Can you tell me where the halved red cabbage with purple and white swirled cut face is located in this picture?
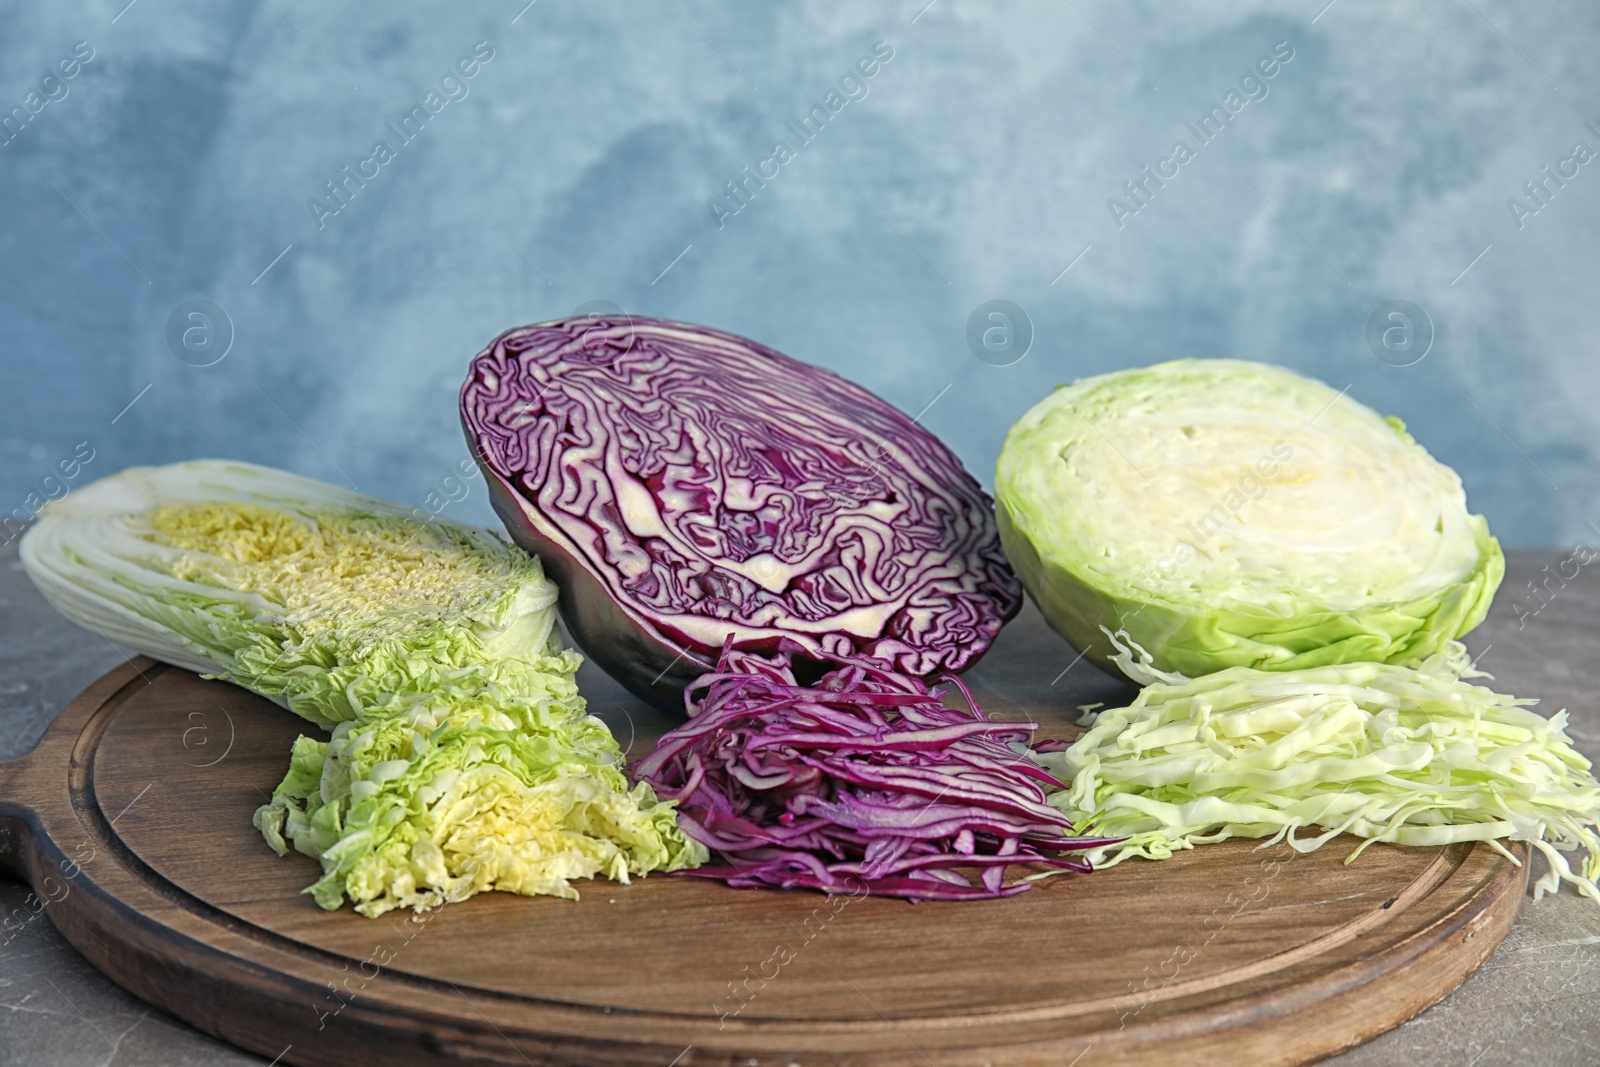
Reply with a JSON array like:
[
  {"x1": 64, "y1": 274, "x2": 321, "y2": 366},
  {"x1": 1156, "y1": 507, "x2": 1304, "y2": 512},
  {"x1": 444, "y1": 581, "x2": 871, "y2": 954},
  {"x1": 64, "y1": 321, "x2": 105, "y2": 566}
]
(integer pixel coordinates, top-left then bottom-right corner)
[{"x1": 461, "y1": 315, "x2": 1021, "y2": 709}]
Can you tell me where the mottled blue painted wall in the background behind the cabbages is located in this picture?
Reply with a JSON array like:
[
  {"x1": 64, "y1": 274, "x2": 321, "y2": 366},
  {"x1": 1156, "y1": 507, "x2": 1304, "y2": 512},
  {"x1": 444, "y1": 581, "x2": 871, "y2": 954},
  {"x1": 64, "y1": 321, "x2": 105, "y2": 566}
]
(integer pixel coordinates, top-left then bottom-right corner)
[{"x1": 0, "y1": 0, "x2": 1600, "y2": 544}]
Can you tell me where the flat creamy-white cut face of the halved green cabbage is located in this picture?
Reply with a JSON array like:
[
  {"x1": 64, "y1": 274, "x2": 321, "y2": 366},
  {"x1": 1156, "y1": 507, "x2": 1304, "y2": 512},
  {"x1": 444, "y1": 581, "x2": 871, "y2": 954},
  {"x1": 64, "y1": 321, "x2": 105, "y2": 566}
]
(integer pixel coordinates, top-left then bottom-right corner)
[{"x1": 1000, "y1": 360, "x2": 1478, "y2": 614}]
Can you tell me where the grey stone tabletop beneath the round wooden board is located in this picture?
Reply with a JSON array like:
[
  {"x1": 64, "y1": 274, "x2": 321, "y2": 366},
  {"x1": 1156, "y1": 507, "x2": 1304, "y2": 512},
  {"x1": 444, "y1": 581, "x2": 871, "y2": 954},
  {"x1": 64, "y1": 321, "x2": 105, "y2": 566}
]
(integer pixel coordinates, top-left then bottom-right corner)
[{"x1": 0, "y1": 547, "x2": 1600, "y2": 1067}]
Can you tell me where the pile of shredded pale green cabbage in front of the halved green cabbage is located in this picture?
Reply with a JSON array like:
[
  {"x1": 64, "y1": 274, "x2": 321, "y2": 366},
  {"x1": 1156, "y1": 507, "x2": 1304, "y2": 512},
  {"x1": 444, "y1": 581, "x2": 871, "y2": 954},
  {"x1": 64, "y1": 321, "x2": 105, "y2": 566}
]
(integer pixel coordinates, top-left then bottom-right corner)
[{"x1": 1037, "y1": 633, "x2": 1600, "y2": 902}]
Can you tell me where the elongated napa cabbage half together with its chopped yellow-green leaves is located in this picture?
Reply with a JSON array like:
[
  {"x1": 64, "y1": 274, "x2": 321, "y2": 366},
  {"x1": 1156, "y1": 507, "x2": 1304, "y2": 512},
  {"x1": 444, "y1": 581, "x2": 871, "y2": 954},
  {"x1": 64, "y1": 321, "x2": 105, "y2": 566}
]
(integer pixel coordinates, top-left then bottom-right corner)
[{"x1": 21, "y1": 461, "x2": 706, "y2": 915}]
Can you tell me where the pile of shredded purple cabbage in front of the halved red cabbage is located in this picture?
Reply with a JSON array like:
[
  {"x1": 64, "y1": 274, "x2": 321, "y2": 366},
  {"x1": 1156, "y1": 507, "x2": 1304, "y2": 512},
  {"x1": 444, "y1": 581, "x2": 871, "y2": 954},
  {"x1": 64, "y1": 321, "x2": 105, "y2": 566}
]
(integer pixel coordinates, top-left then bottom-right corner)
[{"x1": 632, "y1": 641, "x2": 1110, "y2": 901}]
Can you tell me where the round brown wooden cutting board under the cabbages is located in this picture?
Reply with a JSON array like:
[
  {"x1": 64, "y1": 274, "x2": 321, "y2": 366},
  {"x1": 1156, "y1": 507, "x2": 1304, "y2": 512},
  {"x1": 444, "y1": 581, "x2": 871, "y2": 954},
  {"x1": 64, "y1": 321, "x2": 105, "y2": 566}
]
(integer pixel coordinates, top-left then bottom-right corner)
[{"x1": 0, "y1": 613, "x2": 1528, "y2": 1067}]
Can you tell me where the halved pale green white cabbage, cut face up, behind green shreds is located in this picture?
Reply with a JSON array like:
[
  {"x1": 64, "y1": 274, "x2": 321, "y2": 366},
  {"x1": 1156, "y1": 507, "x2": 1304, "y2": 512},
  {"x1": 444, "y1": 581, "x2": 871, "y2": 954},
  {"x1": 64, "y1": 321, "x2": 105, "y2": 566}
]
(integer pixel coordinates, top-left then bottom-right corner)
[{"x1": 995, "y1": 360, "x2": 1506, "y2": 675}]
